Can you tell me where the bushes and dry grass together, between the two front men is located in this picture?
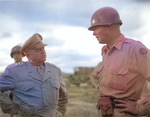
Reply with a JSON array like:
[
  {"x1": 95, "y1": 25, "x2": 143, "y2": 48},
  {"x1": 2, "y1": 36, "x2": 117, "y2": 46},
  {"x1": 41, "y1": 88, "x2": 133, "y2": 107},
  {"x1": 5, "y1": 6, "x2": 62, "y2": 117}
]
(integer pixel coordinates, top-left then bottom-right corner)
[{"x1": 63, "y1": 68, "x2": 101, "y2": 117}]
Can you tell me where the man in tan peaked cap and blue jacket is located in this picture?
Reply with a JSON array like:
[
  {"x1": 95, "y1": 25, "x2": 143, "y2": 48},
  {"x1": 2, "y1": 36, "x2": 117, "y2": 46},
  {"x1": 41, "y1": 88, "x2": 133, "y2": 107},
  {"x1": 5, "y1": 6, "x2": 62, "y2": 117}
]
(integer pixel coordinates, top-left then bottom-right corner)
[{"x1": 0, "y1": 33, "x2": 68, "y2": 117}]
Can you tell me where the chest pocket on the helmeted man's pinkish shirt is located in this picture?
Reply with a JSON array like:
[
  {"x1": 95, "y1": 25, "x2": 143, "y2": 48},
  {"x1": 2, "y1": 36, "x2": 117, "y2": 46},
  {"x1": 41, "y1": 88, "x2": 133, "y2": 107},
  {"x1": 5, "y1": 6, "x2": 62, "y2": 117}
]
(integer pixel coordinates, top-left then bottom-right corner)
[{"x1": 106, "y1": 67, "x2": 128, "y2": 91}]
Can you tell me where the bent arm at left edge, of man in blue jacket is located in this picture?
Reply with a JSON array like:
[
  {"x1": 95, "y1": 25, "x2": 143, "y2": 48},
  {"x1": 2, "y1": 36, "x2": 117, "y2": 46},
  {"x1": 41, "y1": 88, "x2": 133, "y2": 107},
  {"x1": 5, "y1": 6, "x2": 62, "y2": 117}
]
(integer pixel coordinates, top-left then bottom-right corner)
[{"x1": 0, "y1": 66, "x2": 19, "y2": 115}]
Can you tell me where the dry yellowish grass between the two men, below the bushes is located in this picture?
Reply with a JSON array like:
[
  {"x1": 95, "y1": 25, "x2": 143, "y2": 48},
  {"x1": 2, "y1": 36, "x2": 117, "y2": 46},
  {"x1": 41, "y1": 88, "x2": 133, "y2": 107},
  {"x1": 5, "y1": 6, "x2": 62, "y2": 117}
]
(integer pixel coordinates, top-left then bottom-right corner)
[{"x1": 65, "y1": 86, "x2": 100, "y2": 117}]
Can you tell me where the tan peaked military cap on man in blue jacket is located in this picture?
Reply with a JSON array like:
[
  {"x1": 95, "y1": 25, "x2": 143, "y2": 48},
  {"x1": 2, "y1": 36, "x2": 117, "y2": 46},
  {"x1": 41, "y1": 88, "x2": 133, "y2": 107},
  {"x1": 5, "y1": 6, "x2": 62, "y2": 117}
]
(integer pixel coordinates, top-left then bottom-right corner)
[{"x1": 20, "y1": 33, "x2": 47, "y2": 56}]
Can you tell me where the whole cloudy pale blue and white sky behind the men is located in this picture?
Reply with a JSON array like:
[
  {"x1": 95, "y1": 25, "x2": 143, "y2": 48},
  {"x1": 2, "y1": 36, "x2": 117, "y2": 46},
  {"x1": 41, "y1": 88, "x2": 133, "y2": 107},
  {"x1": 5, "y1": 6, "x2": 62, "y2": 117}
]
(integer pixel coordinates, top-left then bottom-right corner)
[{"x1": 0, "y1": 0, "x2": 150, "y2": 73}]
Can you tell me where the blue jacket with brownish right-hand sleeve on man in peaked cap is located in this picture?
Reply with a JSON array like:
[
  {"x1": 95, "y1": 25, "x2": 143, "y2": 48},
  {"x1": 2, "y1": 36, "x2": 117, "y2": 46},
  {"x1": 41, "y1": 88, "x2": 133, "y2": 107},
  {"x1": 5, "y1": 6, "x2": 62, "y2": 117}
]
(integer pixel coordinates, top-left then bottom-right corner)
[{"x1": 0, "y1": 62, "x2": 68, "y2": 117}]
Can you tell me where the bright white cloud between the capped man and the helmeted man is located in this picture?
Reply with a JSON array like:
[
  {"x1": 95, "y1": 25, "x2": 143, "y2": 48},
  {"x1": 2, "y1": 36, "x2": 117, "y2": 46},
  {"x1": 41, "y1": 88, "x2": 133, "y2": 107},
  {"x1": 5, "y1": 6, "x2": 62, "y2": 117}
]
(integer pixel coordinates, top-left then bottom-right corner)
[{"x1": 43, "y1": 25, "x2": 102, "y2": 72}]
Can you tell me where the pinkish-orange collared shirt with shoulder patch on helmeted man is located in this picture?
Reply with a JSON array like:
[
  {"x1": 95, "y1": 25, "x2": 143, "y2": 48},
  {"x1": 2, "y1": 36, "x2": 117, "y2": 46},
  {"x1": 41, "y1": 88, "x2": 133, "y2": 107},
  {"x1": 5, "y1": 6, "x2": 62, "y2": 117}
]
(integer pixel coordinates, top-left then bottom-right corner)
[{"x1": 99, "y1": 34, "x2": 150, "y2": 100}]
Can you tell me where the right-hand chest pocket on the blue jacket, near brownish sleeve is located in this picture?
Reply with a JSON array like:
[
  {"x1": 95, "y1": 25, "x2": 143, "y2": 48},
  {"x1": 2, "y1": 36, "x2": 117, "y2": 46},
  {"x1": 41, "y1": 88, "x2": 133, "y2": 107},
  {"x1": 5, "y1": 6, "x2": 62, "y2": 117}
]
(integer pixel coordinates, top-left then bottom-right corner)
[{"x1": 51, "y1": 81, "x2": 60, "y2": 101}]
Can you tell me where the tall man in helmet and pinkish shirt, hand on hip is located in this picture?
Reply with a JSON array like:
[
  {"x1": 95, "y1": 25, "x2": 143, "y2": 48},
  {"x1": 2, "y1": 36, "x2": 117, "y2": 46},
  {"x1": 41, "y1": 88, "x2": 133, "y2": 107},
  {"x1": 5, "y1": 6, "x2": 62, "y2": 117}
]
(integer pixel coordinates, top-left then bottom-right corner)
[{"x1": 89, "y1": 7, "x2": 150, "y2": 117}]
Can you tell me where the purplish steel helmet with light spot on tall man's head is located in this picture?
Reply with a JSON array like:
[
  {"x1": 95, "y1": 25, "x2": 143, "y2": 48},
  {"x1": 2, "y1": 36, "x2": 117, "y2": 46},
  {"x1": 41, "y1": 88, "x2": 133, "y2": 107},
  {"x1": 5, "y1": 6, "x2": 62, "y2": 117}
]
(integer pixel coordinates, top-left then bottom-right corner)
[{"x1": 88, "y1": 7, "x2": 122, "y2": 30}]
